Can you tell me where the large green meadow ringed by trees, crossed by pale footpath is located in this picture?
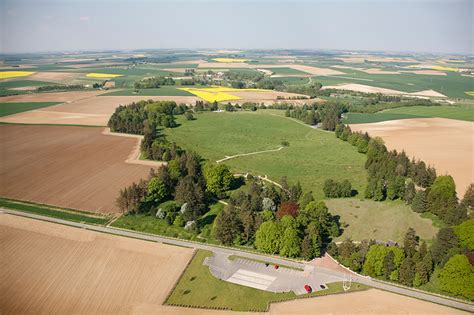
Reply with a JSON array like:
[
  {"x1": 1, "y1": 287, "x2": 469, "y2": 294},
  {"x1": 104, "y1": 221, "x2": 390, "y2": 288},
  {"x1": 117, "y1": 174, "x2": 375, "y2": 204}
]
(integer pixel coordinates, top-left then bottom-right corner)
[{"x1": 165, "y1": 110, "x2": 367, "y2": 198}]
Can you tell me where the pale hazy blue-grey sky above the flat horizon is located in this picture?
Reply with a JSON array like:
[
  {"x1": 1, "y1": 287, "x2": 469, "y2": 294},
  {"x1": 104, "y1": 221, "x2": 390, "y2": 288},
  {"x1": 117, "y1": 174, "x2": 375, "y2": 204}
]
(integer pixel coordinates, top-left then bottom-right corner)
[{"x1": 0, "y1": 0, "x2": 474, "y2": 54}]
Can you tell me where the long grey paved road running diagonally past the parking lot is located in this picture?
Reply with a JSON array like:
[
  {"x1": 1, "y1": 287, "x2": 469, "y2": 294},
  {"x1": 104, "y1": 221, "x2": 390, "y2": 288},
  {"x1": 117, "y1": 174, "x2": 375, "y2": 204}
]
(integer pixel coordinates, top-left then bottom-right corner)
[{"x1": 0, "y1": 208, "x2": 474, "y2": 312}]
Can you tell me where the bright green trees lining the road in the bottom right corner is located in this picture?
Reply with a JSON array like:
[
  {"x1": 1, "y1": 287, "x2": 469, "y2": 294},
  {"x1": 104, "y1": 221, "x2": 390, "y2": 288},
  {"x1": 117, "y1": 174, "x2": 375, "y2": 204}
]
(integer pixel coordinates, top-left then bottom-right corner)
[{"x1": 328, "y1": 219, "x2": 474, "y2": 300}]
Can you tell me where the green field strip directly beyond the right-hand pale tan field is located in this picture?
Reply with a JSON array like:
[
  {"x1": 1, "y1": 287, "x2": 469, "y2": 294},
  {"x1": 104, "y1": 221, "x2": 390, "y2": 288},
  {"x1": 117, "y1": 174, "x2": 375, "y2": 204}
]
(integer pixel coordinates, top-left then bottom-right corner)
[{"x1": 344, "y1": 105, "x2": 474, "y2": 124}]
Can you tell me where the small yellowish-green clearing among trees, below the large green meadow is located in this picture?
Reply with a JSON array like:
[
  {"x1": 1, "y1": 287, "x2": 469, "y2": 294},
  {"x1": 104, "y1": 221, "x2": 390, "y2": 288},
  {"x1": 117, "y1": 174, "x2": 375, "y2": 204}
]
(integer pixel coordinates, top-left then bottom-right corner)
[{"x1": 326, "y1": 198, "x2": 438, "y2": 243}]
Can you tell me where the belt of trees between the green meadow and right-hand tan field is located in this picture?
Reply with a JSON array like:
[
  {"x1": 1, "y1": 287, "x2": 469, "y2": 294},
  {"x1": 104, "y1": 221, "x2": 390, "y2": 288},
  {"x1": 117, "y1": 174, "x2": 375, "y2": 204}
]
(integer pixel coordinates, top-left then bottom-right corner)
[{"x1": 335, "y1": 125, "x2": 467, "y2": 225}]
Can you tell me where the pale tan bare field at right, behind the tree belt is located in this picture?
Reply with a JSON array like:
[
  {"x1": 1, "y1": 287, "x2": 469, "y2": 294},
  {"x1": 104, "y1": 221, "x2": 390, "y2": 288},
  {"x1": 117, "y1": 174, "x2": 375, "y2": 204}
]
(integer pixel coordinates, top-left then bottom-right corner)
[{"x1": 350, "y1": 118, "x2": 474, "y2": 197}]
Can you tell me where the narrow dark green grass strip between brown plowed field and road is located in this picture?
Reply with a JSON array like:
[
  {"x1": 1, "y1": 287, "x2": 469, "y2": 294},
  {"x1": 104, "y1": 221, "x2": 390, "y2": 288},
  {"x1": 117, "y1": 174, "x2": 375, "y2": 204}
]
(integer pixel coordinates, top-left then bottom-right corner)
[{"x1": 0, "y1": 198, "x2": 109, "y2": 225}]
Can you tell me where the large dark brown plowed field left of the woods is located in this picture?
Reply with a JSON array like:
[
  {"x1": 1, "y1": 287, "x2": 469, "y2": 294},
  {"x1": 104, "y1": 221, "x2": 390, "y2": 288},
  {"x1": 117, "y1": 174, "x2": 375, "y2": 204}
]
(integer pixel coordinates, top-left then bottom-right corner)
[{"x1": 0, "y1": 125, "x2": 155, "y2": 213}]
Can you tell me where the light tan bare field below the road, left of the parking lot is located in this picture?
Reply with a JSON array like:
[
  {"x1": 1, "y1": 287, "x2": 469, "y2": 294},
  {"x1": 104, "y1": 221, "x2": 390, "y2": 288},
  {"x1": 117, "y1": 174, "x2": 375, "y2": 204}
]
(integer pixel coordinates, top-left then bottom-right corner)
[{"x1": 0, "y1": 214, "x2": 192, "y2": 314}]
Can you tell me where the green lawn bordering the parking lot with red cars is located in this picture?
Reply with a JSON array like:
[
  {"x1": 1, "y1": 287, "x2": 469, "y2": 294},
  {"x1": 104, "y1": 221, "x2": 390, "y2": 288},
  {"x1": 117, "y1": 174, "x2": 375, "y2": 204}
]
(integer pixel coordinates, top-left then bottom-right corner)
[{"x1": 165, "y1": 250, "x2": 368, "y2": 312}]
